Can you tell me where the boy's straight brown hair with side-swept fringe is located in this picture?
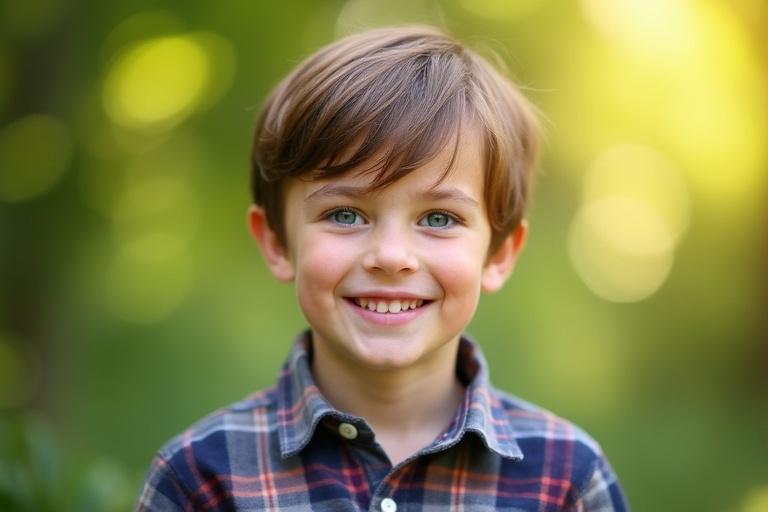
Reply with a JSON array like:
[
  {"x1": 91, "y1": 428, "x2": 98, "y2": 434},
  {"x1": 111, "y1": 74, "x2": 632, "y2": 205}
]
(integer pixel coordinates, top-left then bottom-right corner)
[{"x1": 251, "y1": 27, "x2": 538, "y2": 251}]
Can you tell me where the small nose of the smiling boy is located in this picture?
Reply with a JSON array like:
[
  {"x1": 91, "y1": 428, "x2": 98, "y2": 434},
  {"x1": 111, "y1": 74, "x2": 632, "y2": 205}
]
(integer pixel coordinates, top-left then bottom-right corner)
[{"x1": 363, "y1": 221, "x2": 419, "y2": 275}]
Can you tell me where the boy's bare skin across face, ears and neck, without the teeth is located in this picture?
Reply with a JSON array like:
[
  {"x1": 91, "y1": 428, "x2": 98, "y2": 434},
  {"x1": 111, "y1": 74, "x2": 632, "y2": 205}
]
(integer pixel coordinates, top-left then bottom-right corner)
[{"x1": 249, "y1": 132, "x2": 526, "y2": 464}]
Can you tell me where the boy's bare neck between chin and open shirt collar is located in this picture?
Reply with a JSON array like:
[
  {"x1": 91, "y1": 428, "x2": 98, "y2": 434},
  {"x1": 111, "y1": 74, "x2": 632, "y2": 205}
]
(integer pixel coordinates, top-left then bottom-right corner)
[{"x1": 312, "y1": 338, "x2": 464, "y2": 464}]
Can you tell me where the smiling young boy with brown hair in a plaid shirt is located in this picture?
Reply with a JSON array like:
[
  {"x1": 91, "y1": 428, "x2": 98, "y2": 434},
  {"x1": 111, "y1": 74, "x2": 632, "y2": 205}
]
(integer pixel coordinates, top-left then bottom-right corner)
[{"x1": 138, "y1": 27, "x2": 626, "y2": 512}]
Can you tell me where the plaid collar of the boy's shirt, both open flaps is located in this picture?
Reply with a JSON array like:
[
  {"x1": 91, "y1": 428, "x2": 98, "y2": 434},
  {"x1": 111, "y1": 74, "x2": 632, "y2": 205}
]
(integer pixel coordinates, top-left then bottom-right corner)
[{"x1": 277, "y1": 331, "x2": 523, "y2": 460}]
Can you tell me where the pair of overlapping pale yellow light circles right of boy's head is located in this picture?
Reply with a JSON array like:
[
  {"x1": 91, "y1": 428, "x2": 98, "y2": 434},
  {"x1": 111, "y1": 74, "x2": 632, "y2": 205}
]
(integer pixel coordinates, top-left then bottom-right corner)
[{"x1": 569, "y1": 144, "x2": 691, "y2": 302}]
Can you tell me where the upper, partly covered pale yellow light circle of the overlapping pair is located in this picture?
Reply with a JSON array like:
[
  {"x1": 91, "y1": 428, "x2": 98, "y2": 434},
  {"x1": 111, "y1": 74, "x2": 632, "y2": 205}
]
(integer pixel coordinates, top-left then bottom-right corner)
[{"x1": 582, "y1": 144, "x2": 691, "y2": 238}]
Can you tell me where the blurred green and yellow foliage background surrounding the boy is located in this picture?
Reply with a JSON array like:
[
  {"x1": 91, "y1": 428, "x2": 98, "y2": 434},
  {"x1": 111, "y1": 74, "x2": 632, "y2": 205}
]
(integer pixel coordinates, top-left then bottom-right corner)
[{"x1": 0, "y1": 0, "x2": 768, "y2": 512}]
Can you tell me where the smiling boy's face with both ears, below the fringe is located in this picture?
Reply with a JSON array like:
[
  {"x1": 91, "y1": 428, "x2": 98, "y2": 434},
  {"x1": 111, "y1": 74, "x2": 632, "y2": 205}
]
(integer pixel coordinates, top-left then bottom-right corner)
[{"x1": 251, "y1": 130, "x2": 525, "y2": 369}]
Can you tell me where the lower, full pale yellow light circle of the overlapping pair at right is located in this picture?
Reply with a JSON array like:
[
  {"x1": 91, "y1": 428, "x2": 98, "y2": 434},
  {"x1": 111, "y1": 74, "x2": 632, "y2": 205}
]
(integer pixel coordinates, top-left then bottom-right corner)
[{"x1": 568, "y1": 197, "x2": 675, "y2": 302}]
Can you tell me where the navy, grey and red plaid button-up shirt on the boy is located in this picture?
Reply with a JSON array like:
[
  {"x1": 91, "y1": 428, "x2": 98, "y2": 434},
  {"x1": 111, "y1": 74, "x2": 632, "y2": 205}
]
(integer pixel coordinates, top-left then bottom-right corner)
[{"x1": 137, "y1": 334, "x2": 627, "y2": 512}]
